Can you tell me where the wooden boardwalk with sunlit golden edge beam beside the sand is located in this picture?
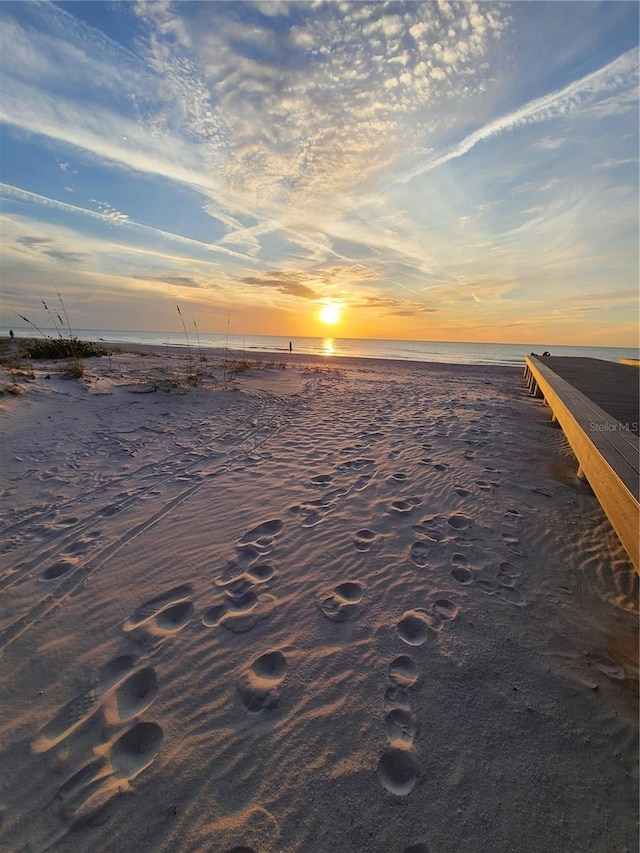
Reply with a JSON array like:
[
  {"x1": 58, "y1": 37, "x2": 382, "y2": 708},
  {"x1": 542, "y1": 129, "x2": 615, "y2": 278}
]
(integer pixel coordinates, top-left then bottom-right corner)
[{"x1": 525, "y1": 355, "x2": 640, "y2": 572}]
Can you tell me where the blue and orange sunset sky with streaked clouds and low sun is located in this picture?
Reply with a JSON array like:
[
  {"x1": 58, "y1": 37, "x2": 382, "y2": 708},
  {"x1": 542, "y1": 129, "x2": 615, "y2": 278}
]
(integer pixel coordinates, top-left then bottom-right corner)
[{"x1": 0, "y1": 0, "x2": 640, "y2": 347}]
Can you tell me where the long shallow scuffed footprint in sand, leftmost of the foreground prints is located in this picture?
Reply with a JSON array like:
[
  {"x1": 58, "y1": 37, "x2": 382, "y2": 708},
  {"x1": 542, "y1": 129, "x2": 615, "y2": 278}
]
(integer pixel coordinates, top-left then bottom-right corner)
[{"x1": 32, "y1": 655, "x2": 136, "y2": 753}]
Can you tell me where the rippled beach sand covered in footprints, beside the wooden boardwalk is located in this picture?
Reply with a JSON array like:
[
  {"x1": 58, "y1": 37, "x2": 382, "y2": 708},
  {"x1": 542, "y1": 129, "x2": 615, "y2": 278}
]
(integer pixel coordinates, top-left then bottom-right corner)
[{"x1": 0, "y1": 349, "x2": 638, "y2": 853}]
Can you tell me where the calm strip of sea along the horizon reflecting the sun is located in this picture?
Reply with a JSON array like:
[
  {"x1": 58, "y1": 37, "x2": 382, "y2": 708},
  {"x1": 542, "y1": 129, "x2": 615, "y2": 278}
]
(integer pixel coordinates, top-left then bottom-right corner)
[{"x1": 0, "y1": 327, "x2": 639, "y2": 366}]
